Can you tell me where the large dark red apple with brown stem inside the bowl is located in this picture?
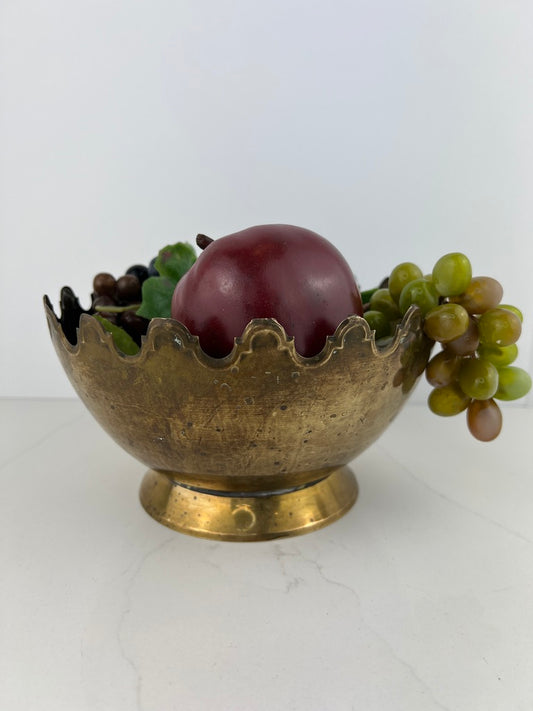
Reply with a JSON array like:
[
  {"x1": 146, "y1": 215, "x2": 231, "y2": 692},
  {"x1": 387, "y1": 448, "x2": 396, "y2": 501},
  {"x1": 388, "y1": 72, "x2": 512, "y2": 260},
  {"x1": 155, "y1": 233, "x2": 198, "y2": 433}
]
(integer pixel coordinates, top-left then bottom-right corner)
[{"x1": 172, "y1": 225, "x2": 363, "y2": 358}]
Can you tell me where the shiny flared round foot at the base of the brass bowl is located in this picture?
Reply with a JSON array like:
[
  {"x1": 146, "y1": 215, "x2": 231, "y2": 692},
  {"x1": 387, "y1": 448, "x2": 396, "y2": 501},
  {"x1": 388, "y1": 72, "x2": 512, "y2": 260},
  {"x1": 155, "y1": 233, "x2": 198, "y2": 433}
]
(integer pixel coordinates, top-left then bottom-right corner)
[{"x1": 140, "y1": 467, "x2": 358, "y2": 541}]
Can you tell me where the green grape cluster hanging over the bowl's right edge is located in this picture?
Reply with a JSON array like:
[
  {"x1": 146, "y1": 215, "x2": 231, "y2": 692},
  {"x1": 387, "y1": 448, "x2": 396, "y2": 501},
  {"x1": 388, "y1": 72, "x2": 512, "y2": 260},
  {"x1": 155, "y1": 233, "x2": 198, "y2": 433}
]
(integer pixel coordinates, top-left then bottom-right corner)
[{"x1": 364, "y1": 252, "x2": 531, "y2": 442}]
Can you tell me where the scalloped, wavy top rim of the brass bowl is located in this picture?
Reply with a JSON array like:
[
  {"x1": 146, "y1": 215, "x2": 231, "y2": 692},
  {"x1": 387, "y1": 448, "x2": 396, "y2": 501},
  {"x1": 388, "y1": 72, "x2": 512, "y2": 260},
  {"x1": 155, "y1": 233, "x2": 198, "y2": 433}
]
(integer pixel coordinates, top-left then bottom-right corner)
[{"x1": 43, "y1": 295, "x2": 422, "y2": 369}]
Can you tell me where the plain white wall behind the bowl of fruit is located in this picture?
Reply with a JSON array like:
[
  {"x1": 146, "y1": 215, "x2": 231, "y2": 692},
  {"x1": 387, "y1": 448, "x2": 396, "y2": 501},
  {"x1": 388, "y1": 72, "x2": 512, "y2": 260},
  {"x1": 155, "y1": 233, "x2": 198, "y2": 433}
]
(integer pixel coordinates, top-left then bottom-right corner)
[{"x1": 0, "y1": 0, "x2": 533, "y2": 406}]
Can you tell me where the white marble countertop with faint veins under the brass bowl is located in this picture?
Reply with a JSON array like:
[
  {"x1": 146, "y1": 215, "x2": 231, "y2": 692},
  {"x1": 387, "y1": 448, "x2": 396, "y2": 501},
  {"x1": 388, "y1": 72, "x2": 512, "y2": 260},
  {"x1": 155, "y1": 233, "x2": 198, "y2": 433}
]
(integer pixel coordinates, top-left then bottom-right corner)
[{"x1": 0, "y1": 400, "x2": 533, "y2": 711}]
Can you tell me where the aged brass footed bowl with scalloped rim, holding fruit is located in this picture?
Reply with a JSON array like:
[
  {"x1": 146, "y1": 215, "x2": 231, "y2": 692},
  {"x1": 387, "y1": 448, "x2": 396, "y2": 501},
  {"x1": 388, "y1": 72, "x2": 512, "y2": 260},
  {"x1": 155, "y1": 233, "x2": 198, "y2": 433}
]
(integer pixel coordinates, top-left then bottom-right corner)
[{"x1": 44, "y1": 297, "x2": 432, "y2": 540}]
